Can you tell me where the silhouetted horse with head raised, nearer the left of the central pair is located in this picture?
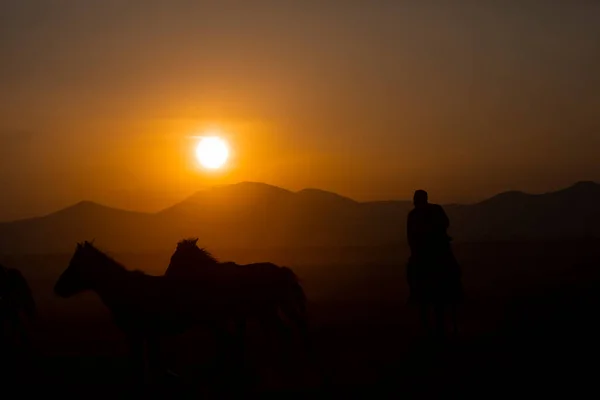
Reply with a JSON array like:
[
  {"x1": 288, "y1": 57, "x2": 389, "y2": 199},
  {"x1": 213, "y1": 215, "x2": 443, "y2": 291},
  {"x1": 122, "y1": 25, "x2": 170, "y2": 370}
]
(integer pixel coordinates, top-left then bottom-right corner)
[{"x1": 54, "y1": 241, "x2": 258, "y2": 379}]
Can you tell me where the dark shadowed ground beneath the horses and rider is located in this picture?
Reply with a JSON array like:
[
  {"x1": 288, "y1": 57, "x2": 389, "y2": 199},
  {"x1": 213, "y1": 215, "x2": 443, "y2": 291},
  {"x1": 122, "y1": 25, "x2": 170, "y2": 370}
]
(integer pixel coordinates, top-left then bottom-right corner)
[{"x1": 0, "y1": 242, "x2": 600, "y2": 398}]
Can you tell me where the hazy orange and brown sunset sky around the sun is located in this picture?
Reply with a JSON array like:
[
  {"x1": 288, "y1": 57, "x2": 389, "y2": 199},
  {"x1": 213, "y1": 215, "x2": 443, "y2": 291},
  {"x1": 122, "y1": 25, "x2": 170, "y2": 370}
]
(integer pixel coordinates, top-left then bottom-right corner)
[{"x1": 0, "y1": 0, "x2": 600, "y2": 219}]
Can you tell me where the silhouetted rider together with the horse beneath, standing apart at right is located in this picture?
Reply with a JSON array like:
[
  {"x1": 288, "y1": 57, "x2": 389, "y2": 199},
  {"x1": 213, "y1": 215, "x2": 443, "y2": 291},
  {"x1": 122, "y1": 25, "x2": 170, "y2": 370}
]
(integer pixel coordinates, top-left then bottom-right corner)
[{"x1": 407, "y1": 190, "x2": 462, "y2": 335}]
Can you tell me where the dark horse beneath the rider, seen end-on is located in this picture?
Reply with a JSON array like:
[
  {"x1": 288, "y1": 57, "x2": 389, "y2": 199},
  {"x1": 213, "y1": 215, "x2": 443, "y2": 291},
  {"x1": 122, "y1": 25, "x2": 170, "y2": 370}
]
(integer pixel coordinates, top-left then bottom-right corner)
[{"x1": 407, "y1": 243, "x2": 463, "y2": 336}]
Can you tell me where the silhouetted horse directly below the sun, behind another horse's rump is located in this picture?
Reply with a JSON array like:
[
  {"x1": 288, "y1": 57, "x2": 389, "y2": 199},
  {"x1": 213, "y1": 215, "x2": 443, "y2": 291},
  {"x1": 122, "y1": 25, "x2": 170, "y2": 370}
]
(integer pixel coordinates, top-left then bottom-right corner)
[{"x1": 165, "y1": 239, "x2": 308, "y2": 352}]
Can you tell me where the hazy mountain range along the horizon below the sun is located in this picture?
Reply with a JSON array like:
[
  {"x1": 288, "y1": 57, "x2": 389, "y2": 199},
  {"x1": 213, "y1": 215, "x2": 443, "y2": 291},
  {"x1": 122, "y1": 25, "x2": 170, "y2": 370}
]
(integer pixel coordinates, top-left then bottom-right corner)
[{"x1": 0, "y1": 182, "x2": 600, "y2": 253}]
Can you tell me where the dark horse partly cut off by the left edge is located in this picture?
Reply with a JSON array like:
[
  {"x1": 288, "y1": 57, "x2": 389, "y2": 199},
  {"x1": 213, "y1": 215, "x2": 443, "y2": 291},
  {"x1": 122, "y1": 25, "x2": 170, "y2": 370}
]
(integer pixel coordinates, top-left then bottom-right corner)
[{"x1": 0, "y1": 265, "x2": 36, "y2": 352}]
